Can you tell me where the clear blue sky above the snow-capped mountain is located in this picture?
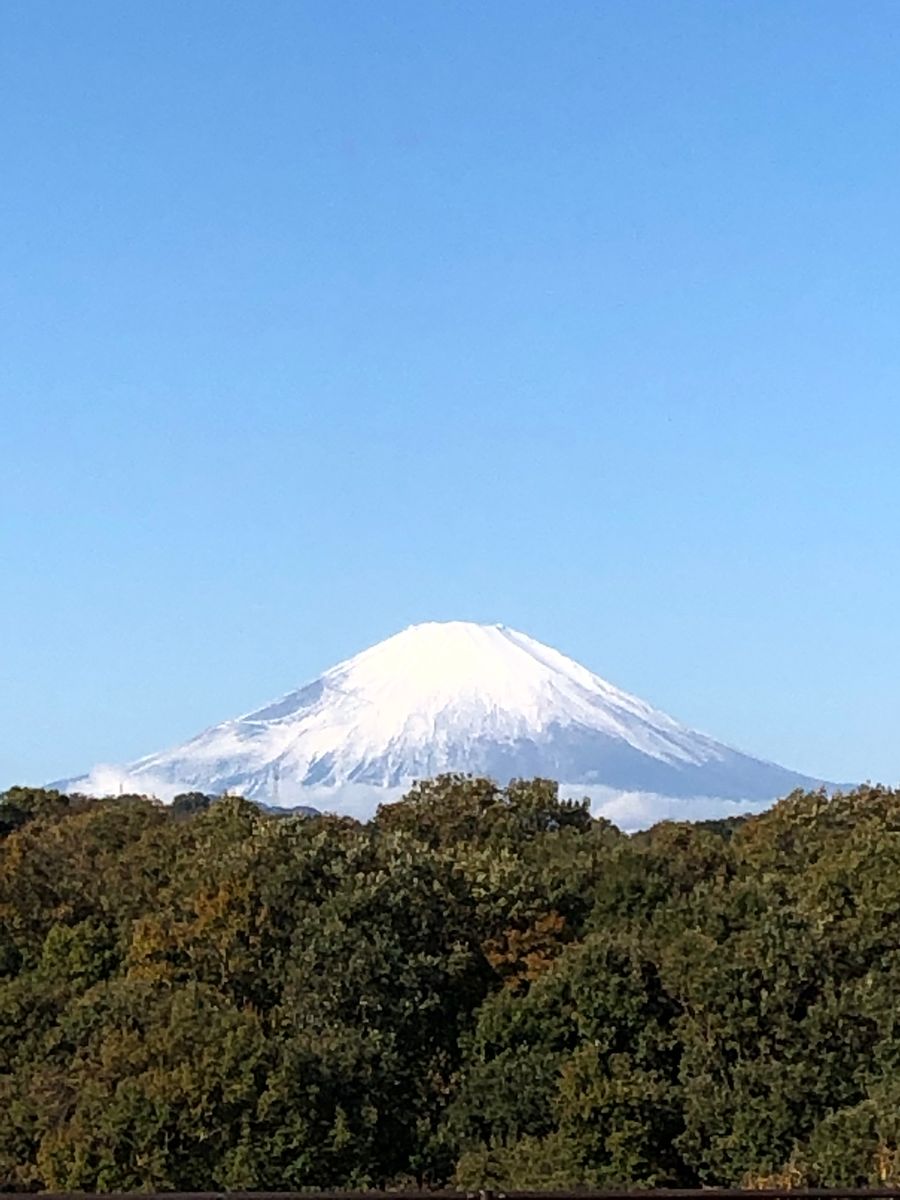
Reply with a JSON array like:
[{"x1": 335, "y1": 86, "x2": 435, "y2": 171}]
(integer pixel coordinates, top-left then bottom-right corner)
[{"x1": 0, "y1": 0, "x2": 900, "y2": 786}]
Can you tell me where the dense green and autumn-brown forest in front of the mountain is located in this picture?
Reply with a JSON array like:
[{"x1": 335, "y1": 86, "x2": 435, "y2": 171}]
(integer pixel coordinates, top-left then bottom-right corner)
[{"x1": 0, "y1": 776, "x2": 900, "y2": 1192}]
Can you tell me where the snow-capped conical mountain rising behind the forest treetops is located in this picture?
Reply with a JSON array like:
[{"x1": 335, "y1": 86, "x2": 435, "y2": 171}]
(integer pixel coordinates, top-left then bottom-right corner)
[{"x1": 56, "y1": 622, "x2": 830, "y2": 829}]
